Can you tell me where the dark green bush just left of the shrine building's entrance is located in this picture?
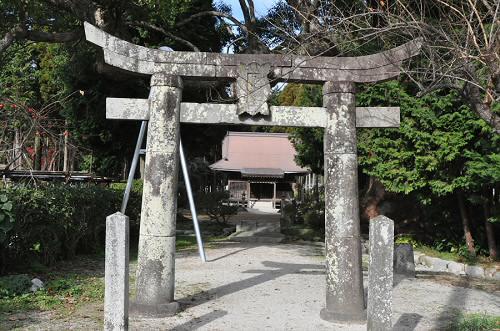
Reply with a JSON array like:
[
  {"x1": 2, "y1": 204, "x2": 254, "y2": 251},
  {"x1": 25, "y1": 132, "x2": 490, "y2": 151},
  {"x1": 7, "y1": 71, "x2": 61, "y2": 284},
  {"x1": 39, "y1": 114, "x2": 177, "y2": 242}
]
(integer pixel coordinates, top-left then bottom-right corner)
[{"x1": 196, "y1": 192, "x2": 238, "y2": 224}]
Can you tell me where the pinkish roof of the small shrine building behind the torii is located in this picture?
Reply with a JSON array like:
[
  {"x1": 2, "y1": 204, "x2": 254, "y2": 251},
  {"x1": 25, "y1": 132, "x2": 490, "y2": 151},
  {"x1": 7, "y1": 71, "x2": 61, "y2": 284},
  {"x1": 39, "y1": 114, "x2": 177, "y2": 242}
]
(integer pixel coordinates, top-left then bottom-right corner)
[{"x1": 210, "y1": 131, "x2": 307, "y2": 173}]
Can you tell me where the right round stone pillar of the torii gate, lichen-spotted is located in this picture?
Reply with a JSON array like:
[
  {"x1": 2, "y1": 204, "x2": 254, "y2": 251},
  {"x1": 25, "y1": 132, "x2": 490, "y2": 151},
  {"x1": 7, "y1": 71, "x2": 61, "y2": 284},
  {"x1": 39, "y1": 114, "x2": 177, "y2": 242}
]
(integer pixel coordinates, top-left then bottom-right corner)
[{"x1": 321, "y1": 82, "x2": 366, "y2": 323}]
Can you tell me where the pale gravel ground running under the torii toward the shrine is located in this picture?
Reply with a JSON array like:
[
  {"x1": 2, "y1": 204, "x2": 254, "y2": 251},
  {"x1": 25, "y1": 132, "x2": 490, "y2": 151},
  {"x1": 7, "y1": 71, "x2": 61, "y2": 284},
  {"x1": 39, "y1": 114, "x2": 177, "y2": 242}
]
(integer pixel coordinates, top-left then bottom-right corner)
[{"x1": 4, "y1": 243, "x2": 500, "y2": 330}]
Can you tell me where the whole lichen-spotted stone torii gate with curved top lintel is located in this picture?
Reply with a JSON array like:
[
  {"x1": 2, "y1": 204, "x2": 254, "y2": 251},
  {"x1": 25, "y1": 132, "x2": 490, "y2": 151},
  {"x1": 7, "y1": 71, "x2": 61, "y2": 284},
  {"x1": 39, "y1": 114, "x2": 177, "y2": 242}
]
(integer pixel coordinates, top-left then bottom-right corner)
[{"x1": 85, "y1": 23, "x2": 421, "y2": 322}]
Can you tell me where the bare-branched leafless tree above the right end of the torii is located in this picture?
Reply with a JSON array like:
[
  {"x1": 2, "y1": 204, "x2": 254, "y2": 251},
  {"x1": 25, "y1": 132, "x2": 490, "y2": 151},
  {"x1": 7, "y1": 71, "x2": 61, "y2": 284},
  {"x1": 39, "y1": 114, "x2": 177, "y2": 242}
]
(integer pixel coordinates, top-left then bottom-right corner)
[{"x1": 267, "y1": 0, "x2": 500, "y2": 131}]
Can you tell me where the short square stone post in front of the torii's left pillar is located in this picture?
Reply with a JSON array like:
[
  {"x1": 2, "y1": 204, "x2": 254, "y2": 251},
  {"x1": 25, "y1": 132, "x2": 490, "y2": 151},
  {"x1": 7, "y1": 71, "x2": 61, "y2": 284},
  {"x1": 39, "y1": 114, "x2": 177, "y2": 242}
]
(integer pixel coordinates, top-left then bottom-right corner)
[{"x1": 104, "y1": 213, "x2": 129, "y2": 331}]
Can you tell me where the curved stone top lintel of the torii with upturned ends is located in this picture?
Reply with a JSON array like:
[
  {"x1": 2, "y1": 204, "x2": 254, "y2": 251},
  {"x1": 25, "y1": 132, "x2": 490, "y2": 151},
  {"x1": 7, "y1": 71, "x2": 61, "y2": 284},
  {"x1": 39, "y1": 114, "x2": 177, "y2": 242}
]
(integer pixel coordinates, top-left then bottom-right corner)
[{"x1": 85, "y1": 22, "x2": 421, "y2": 83}]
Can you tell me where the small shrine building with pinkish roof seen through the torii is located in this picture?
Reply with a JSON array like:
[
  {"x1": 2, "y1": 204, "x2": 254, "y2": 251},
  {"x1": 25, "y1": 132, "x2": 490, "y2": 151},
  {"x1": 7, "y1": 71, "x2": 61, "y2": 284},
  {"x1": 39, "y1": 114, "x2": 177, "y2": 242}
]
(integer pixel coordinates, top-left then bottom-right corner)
[{"x1": 210, "y1": 131, "x2": 309, "y2": 208}]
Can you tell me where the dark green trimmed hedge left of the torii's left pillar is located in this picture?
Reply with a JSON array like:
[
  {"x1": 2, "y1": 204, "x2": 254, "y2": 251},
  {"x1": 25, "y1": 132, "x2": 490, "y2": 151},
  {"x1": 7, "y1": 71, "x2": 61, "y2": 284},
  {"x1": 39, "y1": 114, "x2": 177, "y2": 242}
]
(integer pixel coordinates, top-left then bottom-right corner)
[{"x1": 0, "y1": 184, "x2": 140, "y2": 273}]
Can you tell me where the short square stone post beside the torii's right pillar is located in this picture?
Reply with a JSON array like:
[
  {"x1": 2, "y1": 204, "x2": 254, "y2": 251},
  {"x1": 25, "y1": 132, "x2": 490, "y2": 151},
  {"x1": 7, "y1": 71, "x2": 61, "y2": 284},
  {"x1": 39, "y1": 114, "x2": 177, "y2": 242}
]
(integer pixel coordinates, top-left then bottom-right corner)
[{"x1": 368, "y1": 216, "x2": 394, "y2": 331}]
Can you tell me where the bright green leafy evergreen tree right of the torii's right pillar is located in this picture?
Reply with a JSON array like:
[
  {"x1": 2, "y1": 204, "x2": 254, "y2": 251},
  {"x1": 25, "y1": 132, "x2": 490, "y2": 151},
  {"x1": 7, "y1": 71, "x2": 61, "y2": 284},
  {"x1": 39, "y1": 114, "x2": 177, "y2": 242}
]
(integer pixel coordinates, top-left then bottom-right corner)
[{"x1": 358, "y1": 82, "x2": 500, "y2": 258}]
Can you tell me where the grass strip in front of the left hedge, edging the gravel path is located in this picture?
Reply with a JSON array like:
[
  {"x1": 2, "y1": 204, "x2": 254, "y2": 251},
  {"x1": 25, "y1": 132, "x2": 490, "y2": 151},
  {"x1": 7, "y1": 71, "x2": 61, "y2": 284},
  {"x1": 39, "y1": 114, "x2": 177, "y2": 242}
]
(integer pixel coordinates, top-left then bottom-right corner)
[{"x1": 0, "y1": 235, "x2": 224, "y2": 320}]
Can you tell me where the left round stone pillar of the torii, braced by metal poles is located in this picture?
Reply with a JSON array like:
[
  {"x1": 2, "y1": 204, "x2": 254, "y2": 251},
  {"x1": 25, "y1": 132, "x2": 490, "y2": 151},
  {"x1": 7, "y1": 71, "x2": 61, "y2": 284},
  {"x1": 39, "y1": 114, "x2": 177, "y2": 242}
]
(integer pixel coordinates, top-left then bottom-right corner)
[{"x1": 131, "y1": 73, "x2": 182, "y2": 317}]
